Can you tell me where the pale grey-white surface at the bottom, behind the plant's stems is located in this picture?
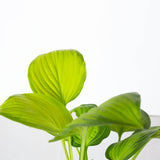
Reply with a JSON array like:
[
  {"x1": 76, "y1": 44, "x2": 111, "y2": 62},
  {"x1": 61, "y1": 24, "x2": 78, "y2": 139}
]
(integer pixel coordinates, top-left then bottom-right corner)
[{"x1": 0, "y1": 116, "x2": 160, "y2": 160}]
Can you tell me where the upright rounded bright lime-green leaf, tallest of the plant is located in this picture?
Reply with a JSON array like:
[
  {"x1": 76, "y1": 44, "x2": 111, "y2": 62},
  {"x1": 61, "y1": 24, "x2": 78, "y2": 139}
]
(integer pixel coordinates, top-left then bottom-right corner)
[{"x1": 28, "y1": 50, "x2": 86, "y2": 104}]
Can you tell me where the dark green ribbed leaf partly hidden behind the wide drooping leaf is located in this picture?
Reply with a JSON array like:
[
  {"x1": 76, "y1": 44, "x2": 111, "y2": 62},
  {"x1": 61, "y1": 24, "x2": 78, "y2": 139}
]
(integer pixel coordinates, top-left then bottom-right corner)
[{"x1": 71, "y1": 104, "x2": 110, "y2": 147}]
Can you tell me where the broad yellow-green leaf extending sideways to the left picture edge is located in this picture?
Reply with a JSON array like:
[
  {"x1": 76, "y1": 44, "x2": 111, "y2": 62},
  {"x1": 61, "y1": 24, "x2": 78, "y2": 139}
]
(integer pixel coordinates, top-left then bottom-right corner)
[{"x1": 0, "y1": 93, "x2": 72, "y2": 136}]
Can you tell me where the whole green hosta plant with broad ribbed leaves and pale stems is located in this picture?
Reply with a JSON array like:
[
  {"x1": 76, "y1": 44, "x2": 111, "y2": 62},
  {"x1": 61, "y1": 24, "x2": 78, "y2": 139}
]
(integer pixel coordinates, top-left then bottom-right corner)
[{"x1": 0, "y1": 50, "x2": 160, "y2": 160}]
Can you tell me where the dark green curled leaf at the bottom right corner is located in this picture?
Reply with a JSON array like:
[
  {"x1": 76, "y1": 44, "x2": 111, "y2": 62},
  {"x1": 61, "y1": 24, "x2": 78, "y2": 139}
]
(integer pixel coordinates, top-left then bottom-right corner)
[{"x1": 105, "y1": 127, "x2": 160, "y2": 160}]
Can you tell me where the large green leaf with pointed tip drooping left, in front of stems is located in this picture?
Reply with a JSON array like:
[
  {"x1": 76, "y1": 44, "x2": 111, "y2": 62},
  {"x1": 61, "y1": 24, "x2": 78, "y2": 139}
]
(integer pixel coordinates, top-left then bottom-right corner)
[{"x1": 51, "y1": 93, "x2": 143, "y2": 141}]
